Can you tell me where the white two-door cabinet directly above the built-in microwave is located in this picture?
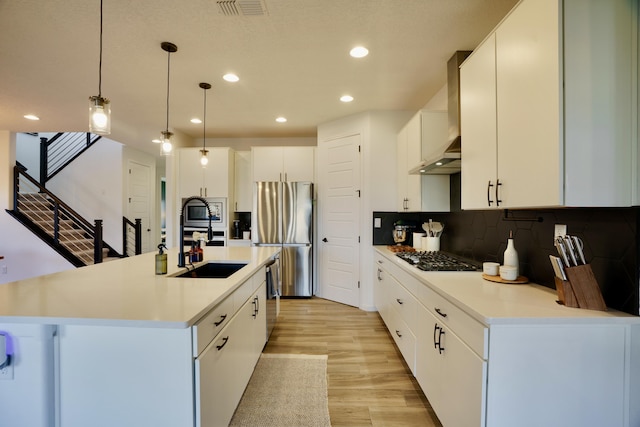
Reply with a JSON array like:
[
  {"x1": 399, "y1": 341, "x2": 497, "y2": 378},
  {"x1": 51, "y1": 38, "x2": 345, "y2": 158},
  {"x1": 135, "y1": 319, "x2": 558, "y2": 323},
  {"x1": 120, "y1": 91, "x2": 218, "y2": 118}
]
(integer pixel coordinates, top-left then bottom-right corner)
[{"x1": 177, "y1": 147, "x2": 235, "y2": 201}]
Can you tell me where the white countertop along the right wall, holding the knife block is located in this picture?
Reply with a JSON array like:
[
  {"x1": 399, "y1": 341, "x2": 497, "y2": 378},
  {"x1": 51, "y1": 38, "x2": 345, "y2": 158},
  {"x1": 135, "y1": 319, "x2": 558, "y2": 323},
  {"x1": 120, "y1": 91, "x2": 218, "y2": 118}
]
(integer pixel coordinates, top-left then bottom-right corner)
[{"x1": 375, "y1": 246, "x2": 640, "y2": 325}]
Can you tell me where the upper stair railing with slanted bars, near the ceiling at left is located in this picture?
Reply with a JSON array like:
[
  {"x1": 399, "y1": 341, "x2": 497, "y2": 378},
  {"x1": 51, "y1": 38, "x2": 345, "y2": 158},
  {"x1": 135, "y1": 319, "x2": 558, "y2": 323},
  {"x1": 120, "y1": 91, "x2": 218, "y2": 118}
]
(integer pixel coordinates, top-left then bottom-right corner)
[{"x1": 40, "y1": 132, "x2": 102, "y2": 186}]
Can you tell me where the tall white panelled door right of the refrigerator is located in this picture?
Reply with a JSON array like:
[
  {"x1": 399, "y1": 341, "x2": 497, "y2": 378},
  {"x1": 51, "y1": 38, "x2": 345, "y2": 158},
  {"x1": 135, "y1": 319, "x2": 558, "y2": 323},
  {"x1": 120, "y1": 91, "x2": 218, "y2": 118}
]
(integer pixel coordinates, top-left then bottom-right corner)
[{"x1": 317, "y1": 134, "x2": 361, "y2": 307}]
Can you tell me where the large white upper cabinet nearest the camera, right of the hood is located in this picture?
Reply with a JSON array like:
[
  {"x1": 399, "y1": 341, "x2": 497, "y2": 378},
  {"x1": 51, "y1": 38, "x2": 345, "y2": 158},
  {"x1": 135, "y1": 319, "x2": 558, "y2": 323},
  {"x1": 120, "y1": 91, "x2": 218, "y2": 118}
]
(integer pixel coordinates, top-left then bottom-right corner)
[{"x1": 460, "y1": 0, "x2": 636, "y2": 209}]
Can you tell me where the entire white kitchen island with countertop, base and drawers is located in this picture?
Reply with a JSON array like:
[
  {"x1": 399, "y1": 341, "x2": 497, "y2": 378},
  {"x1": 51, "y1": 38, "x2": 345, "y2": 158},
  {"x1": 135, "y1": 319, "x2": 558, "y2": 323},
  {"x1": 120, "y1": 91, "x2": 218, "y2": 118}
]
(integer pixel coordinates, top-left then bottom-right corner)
[{"x1": 0, "y1": 247, "x2": 279, "y2": 427}]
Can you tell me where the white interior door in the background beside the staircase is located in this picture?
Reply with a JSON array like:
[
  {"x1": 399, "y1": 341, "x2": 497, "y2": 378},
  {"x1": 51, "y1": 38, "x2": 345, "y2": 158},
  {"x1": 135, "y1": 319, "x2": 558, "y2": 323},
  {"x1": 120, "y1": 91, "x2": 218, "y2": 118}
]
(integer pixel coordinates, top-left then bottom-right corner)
[{"x1": 127, "y1": 160, "x2": 151, "y2": 253}]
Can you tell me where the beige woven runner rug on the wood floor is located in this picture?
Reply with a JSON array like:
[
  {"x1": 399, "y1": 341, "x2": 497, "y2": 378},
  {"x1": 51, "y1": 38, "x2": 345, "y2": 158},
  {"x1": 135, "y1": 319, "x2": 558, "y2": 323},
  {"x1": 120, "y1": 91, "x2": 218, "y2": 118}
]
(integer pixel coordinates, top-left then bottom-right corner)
[{"x1": 229, "y1": 353, "x2": 331, "y2": 427}]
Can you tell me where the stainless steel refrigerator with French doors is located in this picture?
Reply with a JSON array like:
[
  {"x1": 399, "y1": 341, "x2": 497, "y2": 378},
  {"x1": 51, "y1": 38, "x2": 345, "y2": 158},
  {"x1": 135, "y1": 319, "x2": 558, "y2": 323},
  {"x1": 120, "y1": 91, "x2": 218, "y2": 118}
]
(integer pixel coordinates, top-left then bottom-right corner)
[{"x1": 251, "y1": 181, "x2": 314, "y2": 297}]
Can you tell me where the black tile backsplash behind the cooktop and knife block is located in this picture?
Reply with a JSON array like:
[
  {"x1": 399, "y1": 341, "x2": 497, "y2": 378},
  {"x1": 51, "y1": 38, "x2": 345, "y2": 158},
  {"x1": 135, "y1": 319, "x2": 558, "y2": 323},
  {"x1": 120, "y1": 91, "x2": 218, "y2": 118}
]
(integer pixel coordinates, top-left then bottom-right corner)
[{"x1": 373, "y1": 207, "x2": 640, "y2": 315}]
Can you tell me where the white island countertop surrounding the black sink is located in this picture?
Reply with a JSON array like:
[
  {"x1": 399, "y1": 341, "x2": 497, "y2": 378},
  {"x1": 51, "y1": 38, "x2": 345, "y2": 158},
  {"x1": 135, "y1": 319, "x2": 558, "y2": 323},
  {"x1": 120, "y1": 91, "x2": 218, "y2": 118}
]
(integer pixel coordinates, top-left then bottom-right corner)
[{"x1": 0, "y1": 246, "x2": 280, "y2": 328}]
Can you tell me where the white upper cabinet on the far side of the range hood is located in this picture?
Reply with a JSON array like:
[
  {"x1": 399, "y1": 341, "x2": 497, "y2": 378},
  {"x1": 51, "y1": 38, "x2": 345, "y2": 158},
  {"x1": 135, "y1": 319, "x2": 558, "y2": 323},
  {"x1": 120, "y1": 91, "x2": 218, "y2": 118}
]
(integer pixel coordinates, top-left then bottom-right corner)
[{"x1": 396, "y1": 110, "x2": 449, "y2": 212}]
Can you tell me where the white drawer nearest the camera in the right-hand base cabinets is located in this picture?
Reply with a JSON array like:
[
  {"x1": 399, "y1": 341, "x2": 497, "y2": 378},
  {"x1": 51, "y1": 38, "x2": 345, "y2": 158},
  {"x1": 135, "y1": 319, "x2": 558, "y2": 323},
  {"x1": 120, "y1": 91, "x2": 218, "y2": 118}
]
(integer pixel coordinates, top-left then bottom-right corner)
[{"x1": 418, "y1": 285, "x2": 488, "y2": 359}]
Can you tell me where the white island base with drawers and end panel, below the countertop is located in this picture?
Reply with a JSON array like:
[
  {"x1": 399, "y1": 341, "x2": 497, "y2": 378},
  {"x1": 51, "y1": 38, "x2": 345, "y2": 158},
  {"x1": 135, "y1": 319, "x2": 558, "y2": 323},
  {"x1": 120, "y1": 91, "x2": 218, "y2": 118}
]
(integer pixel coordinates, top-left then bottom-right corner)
[{"x1": 56, "y1": 268, "x2": 266, "y2": 427}]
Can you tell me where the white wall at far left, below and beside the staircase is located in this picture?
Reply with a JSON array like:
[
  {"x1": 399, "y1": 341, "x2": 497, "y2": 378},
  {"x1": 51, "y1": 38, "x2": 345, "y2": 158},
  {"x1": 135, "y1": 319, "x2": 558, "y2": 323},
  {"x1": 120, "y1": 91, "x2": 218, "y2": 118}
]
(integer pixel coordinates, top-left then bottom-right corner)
[{"x1": 0, "y1": 131, "x2": 74, "y2": 284}]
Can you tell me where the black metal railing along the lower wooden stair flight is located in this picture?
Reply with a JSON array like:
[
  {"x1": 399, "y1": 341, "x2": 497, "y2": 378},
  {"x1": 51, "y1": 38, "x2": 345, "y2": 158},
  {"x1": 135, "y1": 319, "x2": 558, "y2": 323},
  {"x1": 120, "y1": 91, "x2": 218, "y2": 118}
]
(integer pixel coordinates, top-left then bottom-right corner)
[{"x1": 13, "y1": 165, "x2": 104, "y2": 265}]
